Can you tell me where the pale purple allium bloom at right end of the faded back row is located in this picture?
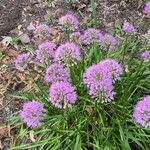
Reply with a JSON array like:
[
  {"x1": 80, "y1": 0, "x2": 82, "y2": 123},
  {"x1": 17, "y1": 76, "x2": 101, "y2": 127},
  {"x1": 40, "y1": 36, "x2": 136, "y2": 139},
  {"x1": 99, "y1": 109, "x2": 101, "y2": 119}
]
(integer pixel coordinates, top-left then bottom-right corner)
[{"x1": 102, "y1": 34, "x2": 118, "y2": 46}]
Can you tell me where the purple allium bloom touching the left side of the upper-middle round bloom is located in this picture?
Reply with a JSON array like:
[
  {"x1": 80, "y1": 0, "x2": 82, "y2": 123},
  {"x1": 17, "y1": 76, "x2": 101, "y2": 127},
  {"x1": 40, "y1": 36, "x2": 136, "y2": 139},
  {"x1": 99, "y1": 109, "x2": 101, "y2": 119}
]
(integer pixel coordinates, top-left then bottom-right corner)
[{"x1": 36, "y1": 42, "x2": 55, "y2": 64}]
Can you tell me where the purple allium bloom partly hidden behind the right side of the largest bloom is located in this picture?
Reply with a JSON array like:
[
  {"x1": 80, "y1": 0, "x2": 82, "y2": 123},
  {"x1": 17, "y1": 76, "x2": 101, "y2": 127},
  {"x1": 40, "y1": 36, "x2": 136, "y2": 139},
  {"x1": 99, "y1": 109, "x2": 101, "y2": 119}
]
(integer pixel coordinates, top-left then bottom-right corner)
[{"x1": 99, "y1": 59, "x2": 123, "y2": 82}]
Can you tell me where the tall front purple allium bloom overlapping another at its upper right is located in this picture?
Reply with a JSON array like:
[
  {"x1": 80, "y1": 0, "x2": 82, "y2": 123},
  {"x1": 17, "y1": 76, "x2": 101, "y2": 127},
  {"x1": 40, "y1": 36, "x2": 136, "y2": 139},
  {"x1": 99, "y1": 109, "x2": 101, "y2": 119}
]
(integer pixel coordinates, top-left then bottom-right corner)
[{"x1": 83, "y1": 64, "x2": 115, "y2": 103}]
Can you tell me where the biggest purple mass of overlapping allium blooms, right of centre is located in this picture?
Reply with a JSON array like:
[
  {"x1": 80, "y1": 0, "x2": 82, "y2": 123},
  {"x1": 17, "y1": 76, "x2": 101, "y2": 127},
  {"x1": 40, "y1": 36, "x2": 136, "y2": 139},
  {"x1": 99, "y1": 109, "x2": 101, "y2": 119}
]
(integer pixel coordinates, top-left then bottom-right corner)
[{"x1": 84, "y1": 59, "x2": 123, "y2": 102}]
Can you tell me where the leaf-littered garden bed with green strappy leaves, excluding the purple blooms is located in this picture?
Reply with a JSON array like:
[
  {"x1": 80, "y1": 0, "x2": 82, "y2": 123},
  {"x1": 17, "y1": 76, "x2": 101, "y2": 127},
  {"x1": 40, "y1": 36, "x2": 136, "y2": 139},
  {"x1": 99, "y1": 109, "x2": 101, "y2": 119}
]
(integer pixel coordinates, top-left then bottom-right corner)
[{"x1": 0, "y1": 0, "x2": 150, "y2": 150}]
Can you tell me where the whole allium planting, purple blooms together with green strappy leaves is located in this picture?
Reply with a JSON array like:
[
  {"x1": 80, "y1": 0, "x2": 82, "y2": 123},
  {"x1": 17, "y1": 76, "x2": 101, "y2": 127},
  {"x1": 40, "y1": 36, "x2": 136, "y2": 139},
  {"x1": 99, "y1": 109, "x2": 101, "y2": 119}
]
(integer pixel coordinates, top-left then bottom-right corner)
[{"x1": 9, "y1": 2, "x2": 150, "y2": 150}]
